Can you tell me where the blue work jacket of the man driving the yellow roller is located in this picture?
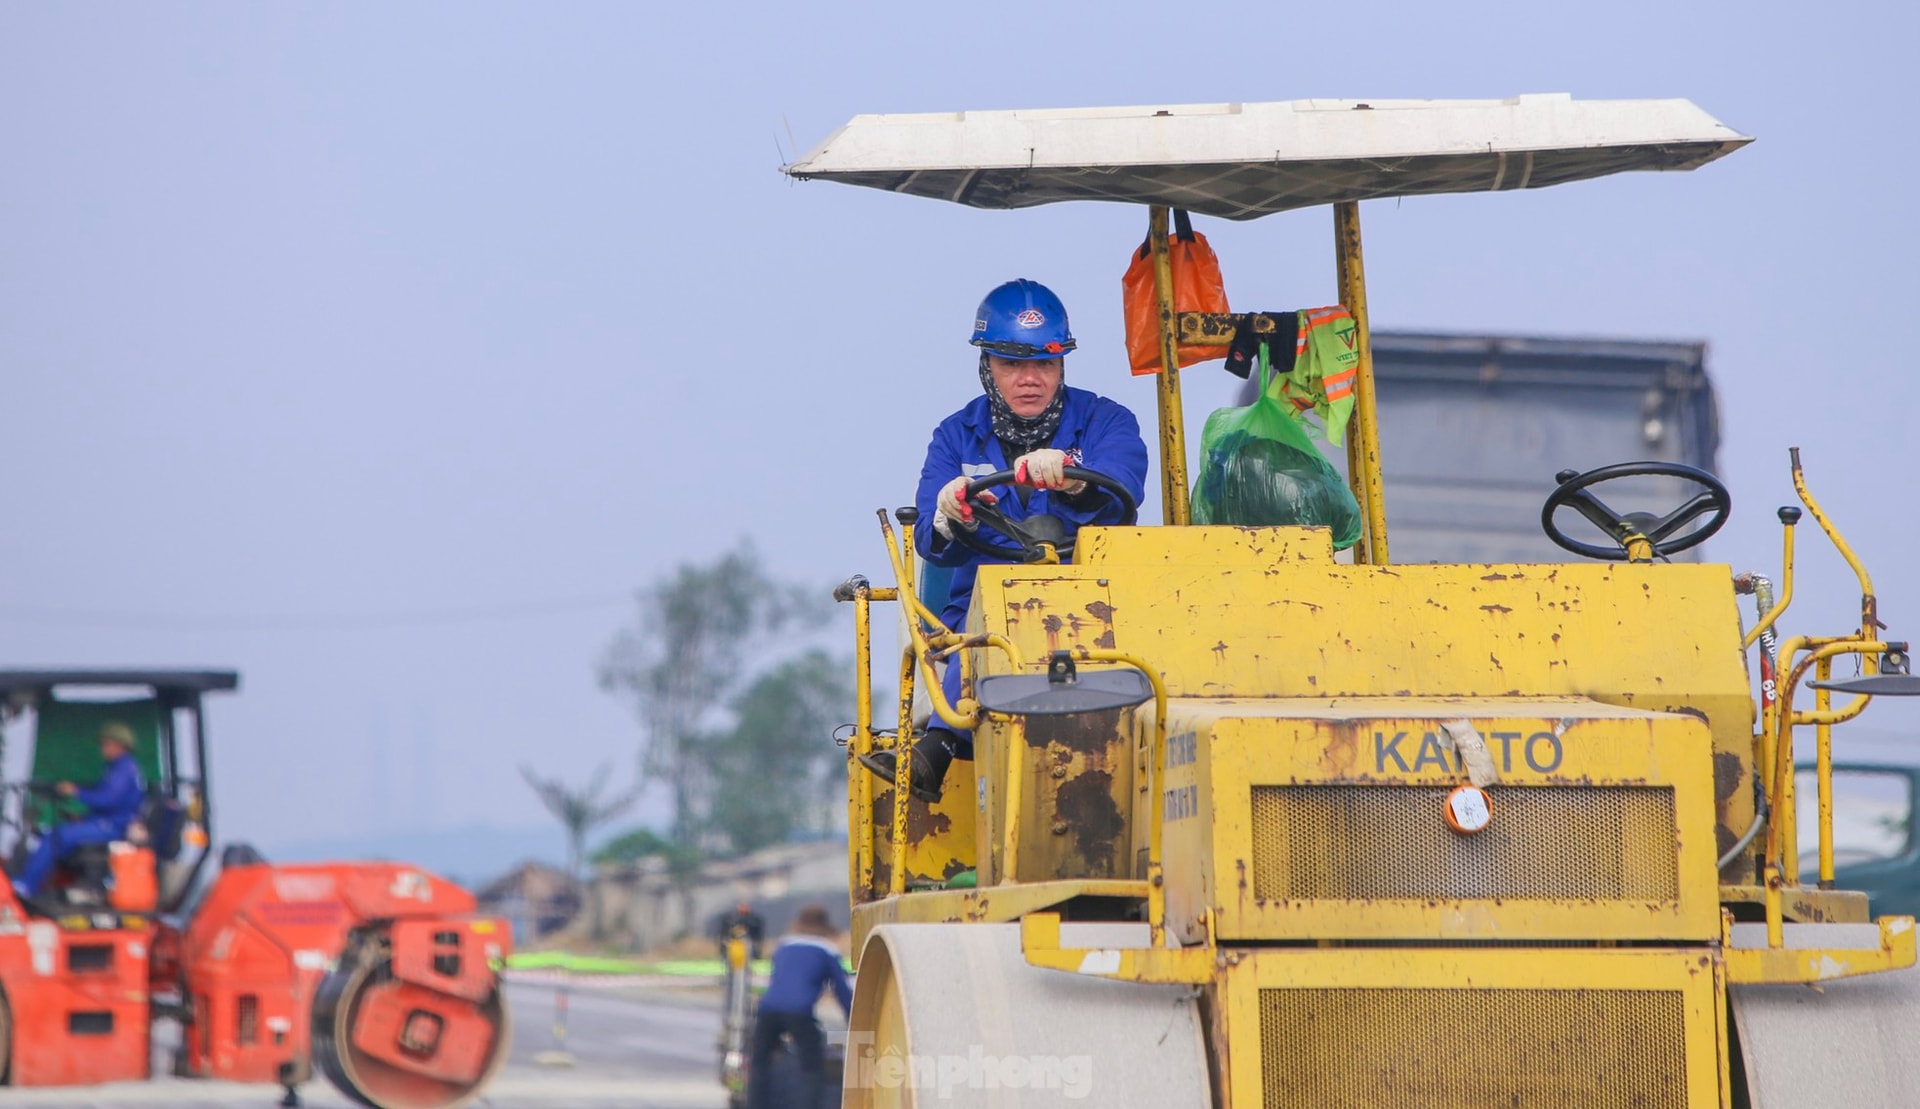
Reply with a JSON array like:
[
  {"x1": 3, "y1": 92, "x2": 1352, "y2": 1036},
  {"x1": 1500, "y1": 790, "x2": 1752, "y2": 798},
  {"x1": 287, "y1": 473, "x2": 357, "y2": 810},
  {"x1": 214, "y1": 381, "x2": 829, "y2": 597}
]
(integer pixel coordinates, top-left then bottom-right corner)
[{"x1": 914, "y1": 386, "x2": 1146, "y2": 631}]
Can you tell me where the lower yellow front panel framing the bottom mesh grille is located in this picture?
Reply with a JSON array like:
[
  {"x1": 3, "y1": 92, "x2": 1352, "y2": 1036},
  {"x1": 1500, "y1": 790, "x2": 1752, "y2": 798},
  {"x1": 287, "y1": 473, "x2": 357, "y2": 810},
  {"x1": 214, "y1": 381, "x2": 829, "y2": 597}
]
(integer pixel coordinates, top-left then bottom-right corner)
[{"x1": 1210, "y1": 948, "x2": 1726, "y2": 1109}]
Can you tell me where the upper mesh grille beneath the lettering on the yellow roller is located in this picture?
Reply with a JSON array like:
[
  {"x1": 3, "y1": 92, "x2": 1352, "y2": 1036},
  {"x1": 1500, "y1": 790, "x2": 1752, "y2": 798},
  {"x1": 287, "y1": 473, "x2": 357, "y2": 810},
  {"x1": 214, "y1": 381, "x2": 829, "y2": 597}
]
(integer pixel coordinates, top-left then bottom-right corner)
[{"x1": 1254, "y1": 785, "x2": 1680, "y2": 902}]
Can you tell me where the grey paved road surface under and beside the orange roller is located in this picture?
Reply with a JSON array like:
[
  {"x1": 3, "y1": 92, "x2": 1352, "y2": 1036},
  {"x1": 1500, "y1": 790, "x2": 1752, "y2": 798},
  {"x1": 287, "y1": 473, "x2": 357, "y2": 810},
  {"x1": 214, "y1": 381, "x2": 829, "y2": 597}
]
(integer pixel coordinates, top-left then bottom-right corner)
[{"x1": 0, "y1": 984, "x2": 726, "y2": 1109}]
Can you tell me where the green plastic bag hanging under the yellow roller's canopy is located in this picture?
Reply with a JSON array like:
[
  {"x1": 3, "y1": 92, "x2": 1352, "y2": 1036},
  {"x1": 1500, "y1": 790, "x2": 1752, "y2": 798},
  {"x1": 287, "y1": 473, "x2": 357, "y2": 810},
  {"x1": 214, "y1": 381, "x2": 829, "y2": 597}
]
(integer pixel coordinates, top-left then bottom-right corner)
[{"x1": 1192, "y1": 343, "x2": 1359, "y2": 551}]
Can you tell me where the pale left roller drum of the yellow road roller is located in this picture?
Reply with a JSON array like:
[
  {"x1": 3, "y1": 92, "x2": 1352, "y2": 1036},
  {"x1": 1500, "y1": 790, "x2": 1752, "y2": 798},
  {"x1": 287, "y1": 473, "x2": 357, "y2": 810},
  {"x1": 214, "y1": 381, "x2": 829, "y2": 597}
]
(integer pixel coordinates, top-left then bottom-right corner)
[{"x1": 843, "y1": 923, "x2": 1213, "y2": 1109}]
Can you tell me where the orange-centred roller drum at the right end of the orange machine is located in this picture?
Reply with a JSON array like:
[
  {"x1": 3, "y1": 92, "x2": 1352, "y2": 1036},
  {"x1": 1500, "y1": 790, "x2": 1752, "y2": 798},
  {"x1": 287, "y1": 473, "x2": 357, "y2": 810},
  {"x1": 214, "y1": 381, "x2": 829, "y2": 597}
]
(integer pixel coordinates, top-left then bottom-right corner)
[{"x1": 313, "y1": 938, "x2": 513, "y2": 1109}]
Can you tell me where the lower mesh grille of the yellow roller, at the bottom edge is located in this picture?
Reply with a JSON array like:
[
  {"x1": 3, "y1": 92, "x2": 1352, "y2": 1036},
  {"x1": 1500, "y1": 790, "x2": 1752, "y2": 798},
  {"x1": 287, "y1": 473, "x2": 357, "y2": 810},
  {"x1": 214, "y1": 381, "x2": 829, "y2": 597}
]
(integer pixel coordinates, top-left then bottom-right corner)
[{"x1": 1260, "y1": 990, "x2": 1688, "y2": 1109}]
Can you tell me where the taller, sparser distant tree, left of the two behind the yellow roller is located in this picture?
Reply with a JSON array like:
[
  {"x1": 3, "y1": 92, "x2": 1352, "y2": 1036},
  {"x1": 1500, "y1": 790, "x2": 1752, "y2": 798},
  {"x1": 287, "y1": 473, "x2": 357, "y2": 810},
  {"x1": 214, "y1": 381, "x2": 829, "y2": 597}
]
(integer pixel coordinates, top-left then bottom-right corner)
[{"x1": 599, "y1": 543, "x2": 828, "y2": 848}]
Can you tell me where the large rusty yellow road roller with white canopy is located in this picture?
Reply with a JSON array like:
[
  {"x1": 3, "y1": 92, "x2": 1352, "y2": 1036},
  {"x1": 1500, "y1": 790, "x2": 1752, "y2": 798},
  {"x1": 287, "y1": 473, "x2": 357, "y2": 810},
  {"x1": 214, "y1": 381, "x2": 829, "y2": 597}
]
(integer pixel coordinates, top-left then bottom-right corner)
[{"x1": 787, "y1": 96, "x2": 1920, "y2": 1109}]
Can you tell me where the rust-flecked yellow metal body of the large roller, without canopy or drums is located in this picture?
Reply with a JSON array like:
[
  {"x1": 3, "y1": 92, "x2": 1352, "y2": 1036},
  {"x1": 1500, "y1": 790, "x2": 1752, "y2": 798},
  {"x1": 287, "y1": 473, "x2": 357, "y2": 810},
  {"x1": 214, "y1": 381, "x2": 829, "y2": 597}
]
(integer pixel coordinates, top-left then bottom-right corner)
[{"x1": 833, "y1": 468, "x2": 1914, "y2": 1107}]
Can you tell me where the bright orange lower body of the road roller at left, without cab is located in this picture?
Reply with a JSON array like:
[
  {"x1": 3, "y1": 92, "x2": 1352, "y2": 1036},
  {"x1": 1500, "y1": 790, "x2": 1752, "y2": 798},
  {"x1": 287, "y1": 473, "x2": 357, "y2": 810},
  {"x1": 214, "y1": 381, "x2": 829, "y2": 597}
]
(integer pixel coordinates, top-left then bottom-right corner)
[{"x1": 0, "y1": 863, "x2": 511, "y2": 1088}]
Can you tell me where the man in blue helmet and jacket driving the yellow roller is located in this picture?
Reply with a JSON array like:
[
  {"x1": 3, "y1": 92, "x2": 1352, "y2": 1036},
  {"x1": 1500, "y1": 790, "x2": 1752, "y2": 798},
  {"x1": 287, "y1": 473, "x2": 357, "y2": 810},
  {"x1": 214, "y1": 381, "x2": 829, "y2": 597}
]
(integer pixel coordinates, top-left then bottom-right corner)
[{"x1": 860, "y1": 278, "x2": 1146, "y2": 800}]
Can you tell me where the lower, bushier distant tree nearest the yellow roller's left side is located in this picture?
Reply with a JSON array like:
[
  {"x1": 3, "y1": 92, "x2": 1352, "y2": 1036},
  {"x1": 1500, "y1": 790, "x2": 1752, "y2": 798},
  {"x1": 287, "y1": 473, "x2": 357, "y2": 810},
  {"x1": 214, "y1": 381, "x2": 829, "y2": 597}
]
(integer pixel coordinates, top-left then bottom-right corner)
[{"x1": 699, "y1": 649, "x2": 852, "y2": 852}]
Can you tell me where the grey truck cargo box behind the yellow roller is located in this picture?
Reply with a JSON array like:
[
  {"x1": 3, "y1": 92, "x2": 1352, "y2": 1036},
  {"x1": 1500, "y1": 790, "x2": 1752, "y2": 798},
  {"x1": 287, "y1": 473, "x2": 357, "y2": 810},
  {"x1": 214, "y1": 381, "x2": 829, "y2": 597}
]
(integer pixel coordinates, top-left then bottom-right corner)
[{"x1": 1240, "y1": 332, "x2": 1720, "y2": 562}]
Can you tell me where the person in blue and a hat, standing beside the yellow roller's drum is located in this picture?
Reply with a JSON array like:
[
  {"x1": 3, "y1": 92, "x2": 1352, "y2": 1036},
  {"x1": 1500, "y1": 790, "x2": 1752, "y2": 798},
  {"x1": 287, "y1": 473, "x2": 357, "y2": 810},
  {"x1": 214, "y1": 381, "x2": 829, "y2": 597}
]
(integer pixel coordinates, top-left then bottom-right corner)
[{"x1": 747, "y1": 906, "x2": 852, "y2": 1109}]
